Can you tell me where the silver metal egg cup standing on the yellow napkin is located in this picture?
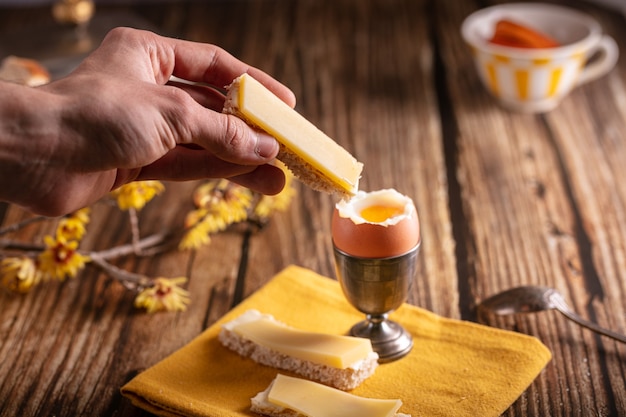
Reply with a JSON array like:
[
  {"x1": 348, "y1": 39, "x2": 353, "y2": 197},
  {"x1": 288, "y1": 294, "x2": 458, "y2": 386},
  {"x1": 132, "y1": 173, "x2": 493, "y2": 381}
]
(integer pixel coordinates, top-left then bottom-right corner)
[{"x1": 333, "y1": 241, "x2": 421, "y2": 363}]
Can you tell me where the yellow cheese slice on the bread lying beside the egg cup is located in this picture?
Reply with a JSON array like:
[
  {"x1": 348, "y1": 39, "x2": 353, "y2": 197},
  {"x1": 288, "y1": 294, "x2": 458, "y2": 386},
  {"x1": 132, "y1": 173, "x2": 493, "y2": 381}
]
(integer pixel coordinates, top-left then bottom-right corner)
[{"x1": 224, "y1": 310, "x2": 373, "y2": 369}]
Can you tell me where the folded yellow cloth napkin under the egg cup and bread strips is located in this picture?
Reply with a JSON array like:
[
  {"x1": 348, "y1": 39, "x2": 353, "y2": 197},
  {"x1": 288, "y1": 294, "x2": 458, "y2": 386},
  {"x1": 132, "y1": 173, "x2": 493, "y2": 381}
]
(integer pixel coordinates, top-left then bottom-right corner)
[{"x1": 122, "y1": 266, "x2": 551, "y2": 417}]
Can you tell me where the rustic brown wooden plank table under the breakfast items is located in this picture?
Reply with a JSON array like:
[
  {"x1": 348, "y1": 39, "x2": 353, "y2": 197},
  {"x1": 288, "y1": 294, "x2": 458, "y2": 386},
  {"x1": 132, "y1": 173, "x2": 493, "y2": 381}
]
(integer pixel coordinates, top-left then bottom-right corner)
[{"x1": 0, "y1": 0, "x2": 626, "y2": 416}]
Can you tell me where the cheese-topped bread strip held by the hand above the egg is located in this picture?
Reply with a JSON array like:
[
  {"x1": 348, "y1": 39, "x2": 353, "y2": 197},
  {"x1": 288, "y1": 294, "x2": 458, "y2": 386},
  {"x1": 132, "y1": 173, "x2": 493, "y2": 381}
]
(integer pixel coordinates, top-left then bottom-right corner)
[{"x1": 223, "y1": 74, "x2": 363, "y2": 198}]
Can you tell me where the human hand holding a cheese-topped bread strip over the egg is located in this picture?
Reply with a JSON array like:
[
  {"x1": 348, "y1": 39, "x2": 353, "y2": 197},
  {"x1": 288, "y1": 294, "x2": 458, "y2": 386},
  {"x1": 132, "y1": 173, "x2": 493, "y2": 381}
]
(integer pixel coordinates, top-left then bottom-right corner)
[{"x1": 0, "y1": 28, "x2": 295, "y2": 215}]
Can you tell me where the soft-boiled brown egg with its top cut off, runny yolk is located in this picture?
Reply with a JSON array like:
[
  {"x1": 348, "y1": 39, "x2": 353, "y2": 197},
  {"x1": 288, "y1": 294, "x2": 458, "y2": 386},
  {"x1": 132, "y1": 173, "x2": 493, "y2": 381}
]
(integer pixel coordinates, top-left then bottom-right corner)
[{"x1": 332, "y1": 189, "x2": 420, "y2": 258}]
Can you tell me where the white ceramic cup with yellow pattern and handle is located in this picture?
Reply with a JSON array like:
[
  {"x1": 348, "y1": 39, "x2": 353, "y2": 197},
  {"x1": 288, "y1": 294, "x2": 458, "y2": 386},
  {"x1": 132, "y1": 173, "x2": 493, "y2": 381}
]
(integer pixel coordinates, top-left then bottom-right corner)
[{"x1": 461, "y1": 3, "x2": 619, "y2": 113}]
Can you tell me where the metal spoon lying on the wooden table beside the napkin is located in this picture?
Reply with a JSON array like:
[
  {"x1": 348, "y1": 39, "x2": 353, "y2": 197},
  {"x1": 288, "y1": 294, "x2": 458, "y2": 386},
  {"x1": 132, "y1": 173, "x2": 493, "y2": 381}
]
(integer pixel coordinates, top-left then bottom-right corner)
[{"x1": 477, "y1": 286, "x2": 626, "y2": 343}]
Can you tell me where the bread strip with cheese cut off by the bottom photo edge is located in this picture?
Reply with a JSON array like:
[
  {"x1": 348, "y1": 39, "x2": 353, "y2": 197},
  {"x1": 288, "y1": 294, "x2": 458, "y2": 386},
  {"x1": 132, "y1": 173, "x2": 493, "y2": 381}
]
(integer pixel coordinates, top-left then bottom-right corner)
[{"x1": 250, "y1": 374, "x2": 411, "y2": 417}]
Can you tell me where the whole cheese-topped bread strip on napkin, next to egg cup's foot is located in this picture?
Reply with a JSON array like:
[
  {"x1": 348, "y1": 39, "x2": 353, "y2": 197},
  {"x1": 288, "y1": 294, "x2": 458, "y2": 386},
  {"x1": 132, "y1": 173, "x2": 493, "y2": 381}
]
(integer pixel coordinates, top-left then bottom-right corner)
[{"x1": 218, "y1": 310, "x2": 378, "y2": 390}]
